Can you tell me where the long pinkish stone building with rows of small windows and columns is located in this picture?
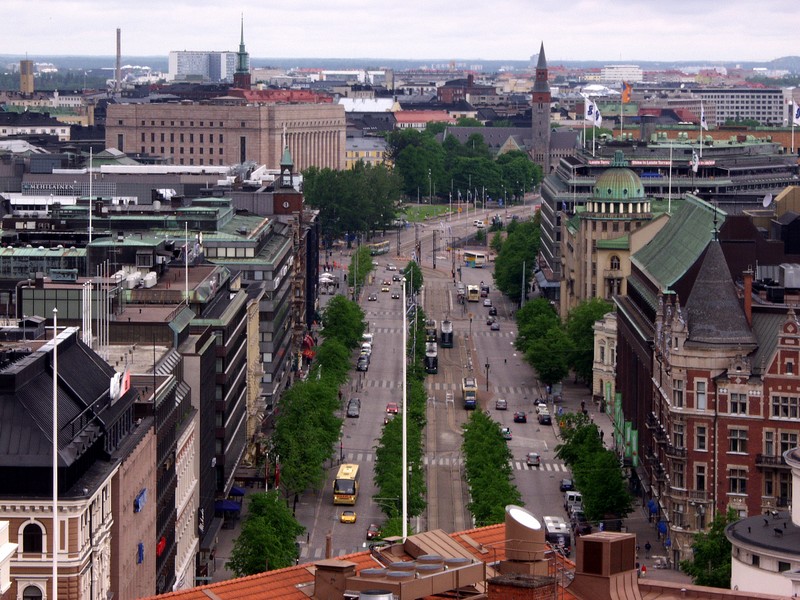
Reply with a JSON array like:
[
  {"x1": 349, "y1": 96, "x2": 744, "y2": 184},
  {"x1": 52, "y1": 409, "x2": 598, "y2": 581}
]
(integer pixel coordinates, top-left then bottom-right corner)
[{"x1": 106, "y1": 100, "x2": 345, "y2": 171}]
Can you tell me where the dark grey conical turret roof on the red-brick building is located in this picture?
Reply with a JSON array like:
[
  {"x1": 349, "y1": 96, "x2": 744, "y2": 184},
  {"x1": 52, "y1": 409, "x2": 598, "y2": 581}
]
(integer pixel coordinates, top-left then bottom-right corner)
[{"x1": 686, "y1": 240, "x2": 756, "y2": 350}]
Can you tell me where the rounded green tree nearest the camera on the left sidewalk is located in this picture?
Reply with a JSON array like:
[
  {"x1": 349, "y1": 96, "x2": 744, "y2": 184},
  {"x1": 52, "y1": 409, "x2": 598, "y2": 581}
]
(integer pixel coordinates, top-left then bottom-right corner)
[{"x1": 225, "y1": 492, "x2": 305, "y2": 577}]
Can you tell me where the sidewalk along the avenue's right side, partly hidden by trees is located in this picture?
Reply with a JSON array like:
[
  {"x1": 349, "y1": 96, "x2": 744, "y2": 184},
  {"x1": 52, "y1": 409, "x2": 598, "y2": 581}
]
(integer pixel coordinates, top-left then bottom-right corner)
[{"x1": 553, "y1": 378, "x2": 692, "y2": 584}]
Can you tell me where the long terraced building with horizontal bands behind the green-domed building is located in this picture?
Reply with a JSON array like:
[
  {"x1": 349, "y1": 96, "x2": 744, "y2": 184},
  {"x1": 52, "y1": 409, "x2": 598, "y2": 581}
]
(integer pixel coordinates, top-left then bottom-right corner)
[{"x1": 536, "y1": 137, "x2": 798, "y2": 303}]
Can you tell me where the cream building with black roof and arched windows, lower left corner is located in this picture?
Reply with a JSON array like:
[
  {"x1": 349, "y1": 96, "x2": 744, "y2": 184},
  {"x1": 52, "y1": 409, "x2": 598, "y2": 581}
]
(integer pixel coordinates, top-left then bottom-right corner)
[{"x1": 0, "y1": 328, "x2": 150, "y2": 600}]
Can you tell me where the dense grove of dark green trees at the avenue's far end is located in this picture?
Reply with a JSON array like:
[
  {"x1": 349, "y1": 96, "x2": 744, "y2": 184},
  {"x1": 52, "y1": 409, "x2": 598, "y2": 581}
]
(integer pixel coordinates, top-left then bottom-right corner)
[{"x1": 303, "y1": 119, "x2": 542, "y2": 246}]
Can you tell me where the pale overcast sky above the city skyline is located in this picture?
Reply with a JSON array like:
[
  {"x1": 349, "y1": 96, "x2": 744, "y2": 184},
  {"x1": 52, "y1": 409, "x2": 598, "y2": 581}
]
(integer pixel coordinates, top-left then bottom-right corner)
[{"x1": 6, "y1": 0, "x2": 800, "y2": 64}]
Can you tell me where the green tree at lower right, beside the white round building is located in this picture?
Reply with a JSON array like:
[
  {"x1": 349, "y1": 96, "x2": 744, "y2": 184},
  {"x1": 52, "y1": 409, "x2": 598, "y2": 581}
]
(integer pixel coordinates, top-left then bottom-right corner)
[{"x1": 681, "y1": 508, "x2": 738, "y2": 589}]
